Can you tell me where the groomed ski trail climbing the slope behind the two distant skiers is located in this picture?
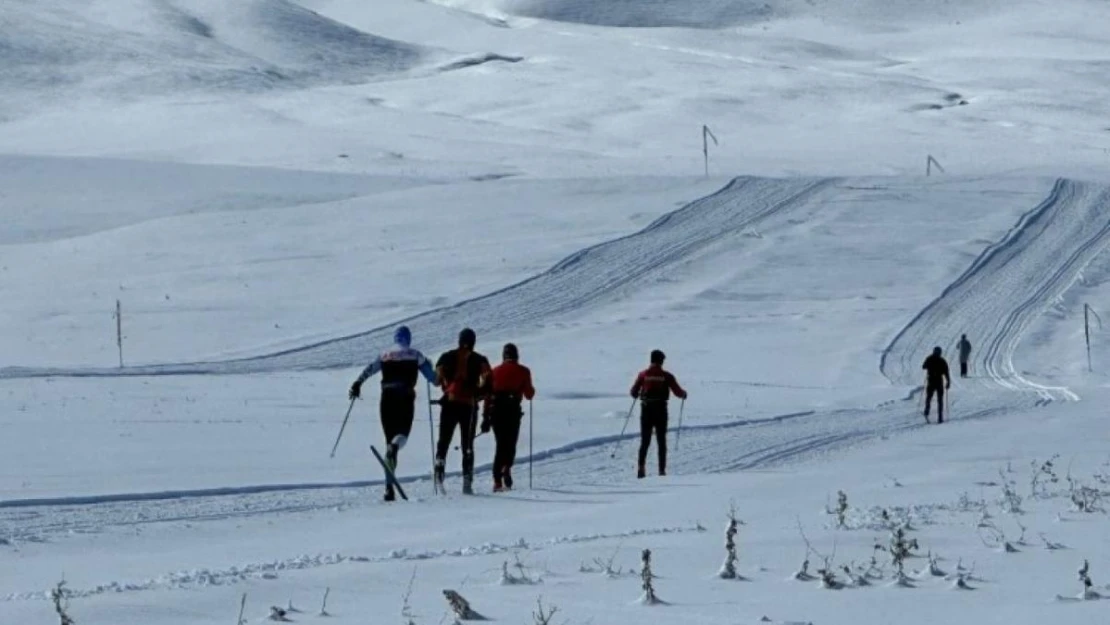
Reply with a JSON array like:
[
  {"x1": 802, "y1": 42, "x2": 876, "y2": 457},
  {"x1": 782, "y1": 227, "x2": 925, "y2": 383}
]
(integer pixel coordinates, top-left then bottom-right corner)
[{"x1": 880, "y1": 179, "x2": 1110, "y2": 404}]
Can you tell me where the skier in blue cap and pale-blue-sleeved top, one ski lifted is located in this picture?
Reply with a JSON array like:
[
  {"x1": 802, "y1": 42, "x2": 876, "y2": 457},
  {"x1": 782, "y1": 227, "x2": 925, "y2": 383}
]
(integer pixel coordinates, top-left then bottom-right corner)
[{"x1": 347, "y1": 325, "x2": 435, "y2": 502}]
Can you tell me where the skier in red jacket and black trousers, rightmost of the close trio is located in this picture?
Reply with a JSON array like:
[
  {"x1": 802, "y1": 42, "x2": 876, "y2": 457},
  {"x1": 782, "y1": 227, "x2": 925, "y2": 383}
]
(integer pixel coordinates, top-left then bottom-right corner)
[{"x1": 482, "y1": 343, "x2": 536, "y2": 493}]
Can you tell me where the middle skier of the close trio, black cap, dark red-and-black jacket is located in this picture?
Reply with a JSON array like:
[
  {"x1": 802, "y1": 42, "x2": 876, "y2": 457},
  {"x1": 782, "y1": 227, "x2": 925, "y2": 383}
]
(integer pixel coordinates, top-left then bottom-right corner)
[{"x1": 435, "y1": 327, "x2": 490, "y2": 495}]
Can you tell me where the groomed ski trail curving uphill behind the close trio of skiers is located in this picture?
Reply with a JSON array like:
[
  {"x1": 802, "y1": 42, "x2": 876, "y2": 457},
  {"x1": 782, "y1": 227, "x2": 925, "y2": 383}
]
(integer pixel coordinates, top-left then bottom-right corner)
[{"x1": 0, "y1": 178, "x2": 837, "y2": 379}]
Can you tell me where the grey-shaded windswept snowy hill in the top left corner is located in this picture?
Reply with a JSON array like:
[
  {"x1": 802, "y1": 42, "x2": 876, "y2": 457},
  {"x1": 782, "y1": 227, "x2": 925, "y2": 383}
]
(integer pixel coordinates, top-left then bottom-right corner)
[{"x1": 0, "y1": 0, "x2": 426, "y2": 114}]
